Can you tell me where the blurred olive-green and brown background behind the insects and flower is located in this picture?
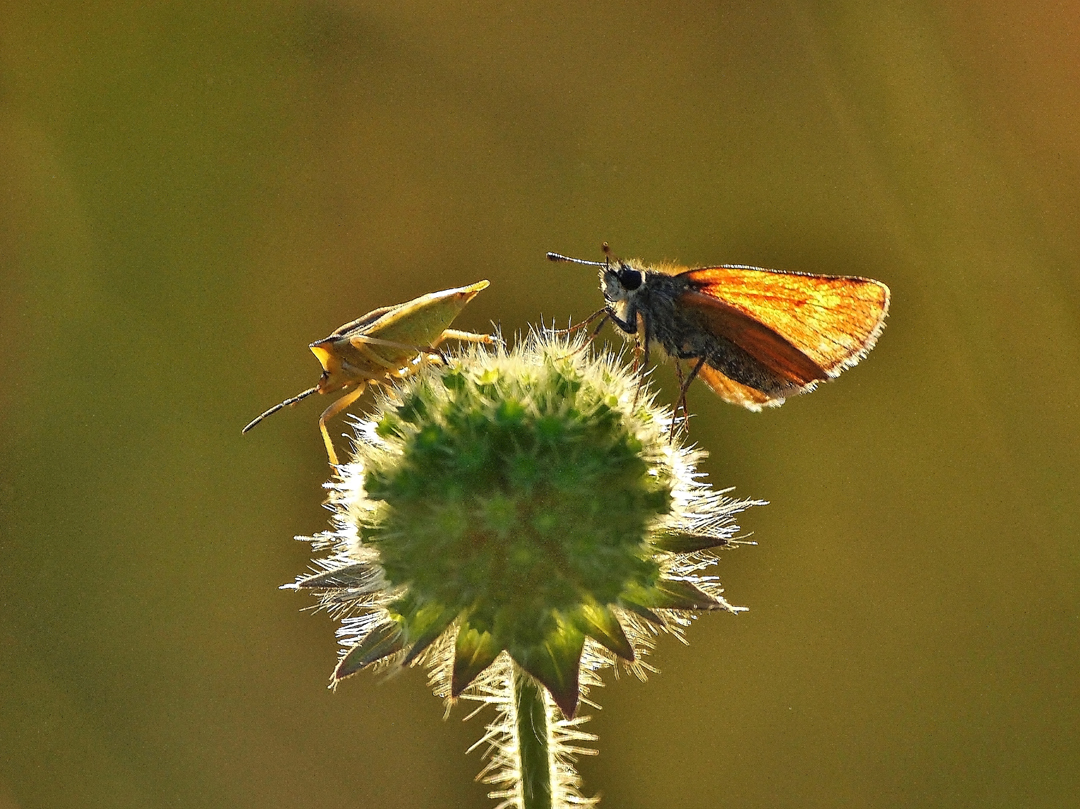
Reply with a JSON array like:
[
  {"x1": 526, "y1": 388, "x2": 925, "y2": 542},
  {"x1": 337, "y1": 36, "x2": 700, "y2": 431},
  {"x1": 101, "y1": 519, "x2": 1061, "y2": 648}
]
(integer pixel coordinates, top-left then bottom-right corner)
[{"x1": 0, "y1": 0, "x2": 1080, "y2": 809}]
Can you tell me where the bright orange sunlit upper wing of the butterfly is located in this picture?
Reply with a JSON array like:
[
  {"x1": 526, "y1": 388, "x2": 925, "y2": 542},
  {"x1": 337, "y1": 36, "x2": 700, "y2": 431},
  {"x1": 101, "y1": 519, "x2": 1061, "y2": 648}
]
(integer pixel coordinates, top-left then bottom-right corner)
[{"x1": 680, "y1": 266, "x2": 889, "y2": 378}]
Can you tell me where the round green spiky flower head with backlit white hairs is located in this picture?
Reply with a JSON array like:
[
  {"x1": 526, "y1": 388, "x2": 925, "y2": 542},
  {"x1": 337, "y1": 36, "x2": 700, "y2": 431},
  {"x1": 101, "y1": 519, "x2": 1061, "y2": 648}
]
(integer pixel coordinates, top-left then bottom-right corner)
[{"x1": 291, "y1": 334, "x2": 751, "y2": 717}]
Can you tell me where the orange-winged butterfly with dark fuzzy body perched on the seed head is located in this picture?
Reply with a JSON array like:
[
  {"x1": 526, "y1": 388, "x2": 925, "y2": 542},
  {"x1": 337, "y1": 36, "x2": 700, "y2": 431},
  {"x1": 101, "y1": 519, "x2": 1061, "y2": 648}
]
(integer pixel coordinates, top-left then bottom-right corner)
[{"x1": 548, "y1": 244, "x2": 889, "y2": 423}]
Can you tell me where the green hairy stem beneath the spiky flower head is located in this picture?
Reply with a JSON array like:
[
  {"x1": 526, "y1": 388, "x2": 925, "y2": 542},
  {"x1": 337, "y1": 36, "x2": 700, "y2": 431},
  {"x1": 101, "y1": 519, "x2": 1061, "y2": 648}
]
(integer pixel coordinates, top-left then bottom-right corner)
[{"x1": 511, "y1": 663, "x2": 555, "y2": 809}]
